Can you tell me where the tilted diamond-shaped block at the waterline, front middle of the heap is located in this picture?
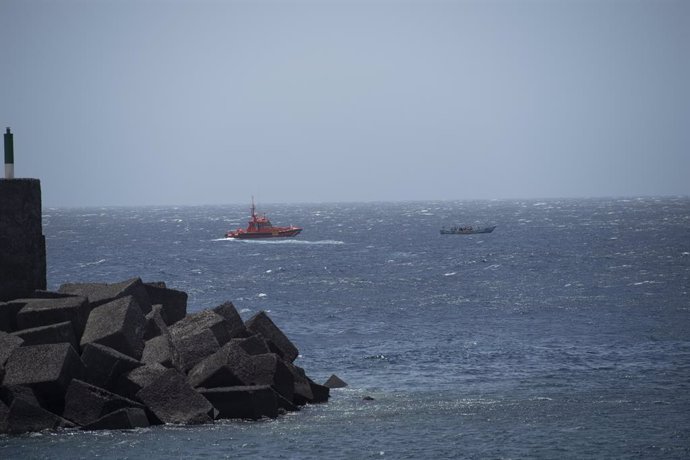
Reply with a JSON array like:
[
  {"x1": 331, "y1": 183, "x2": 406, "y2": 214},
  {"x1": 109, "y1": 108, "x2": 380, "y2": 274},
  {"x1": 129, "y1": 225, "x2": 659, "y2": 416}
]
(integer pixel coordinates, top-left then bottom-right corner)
[{"x1": 136, "y1": 369, "x2": 214, "y2": 424}]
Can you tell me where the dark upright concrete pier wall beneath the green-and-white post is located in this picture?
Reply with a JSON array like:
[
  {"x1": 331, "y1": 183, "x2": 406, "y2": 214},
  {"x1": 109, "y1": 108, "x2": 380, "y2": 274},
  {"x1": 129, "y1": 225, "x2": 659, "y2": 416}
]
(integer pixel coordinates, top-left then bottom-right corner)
[{"x1": 0, "y1": 179, "x2": 46, "y2": 301}]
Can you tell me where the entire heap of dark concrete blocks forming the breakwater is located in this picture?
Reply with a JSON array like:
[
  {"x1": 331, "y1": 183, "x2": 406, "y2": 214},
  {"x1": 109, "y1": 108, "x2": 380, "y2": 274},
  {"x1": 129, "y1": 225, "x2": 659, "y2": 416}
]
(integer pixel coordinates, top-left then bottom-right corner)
[{"x1": 0, "y1": 278, "x2": 329, "y2": 433}]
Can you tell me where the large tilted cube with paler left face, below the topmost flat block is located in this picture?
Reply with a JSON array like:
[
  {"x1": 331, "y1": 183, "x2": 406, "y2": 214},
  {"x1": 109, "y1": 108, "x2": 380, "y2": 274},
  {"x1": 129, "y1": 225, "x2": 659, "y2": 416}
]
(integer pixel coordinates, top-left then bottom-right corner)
[{"x1": 81, "y1": 296, "x2": 145, "y2": 359}]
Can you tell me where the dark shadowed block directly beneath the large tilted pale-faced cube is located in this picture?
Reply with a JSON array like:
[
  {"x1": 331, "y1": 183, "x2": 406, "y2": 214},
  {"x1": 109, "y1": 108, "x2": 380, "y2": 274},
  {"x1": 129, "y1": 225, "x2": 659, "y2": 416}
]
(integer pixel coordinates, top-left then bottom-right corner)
[{"x1": 81, "y1": 343, "x2": 142, "y2": 391}]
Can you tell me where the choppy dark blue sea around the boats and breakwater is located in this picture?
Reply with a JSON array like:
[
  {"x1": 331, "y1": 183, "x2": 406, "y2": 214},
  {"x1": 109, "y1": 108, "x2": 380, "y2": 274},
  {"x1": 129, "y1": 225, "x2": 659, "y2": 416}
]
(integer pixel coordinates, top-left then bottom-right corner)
[{"x1": 0, "y1": 197, "x2": 690, "y2": 460}]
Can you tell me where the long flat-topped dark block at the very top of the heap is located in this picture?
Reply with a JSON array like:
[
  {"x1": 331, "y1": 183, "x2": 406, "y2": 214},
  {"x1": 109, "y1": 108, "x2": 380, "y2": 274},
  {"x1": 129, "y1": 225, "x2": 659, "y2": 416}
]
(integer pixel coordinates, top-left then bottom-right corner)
[{"x1": 58, "y1": 278, "x2": 151, "y2": 315}]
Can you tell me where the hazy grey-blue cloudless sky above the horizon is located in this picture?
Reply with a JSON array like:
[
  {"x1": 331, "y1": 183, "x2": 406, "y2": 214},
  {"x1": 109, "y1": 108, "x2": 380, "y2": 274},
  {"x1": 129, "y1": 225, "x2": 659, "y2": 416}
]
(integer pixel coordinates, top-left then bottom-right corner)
[{"x1": 0, "y1": 0, "x2": 690, "y2": 207}]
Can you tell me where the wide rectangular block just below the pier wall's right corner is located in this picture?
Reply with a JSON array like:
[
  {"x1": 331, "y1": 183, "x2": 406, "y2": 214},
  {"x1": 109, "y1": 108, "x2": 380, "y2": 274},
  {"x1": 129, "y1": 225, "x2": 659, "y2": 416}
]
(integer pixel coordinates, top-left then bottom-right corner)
[{"x1": 17, "y1": 297, "x2": 91, "y2": 338}]
